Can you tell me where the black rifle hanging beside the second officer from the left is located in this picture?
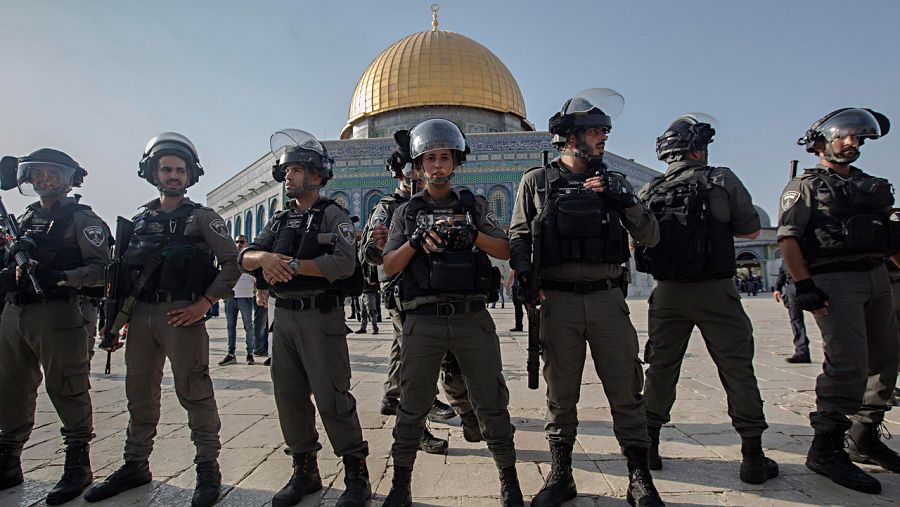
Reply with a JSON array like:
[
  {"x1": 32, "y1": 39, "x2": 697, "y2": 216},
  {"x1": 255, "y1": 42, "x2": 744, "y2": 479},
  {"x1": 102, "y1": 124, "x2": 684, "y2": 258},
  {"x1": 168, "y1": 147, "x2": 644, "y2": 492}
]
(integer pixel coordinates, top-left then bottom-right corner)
[{"x1": 100, "y1": 217, "x2": 136, "y2": 375}]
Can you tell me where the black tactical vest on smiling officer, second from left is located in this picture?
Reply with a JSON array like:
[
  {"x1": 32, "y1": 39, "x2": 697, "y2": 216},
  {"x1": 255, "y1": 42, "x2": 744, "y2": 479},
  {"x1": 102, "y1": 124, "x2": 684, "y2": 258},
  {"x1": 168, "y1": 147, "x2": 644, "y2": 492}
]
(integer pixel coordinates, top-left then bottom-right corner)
[{"x1": 121, "y1": 203, "x2": 218, "y2": 298}]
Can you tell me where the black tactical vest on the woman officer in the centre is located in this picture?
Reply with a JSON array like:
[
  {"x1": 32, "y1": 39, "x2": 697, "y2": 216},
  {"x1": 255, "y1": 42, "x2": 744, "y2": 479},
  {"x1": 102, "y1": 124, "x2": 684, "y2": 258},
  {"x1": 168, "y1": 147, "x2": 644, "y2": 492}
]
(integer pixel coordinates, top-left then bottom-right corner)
[{"x1": 400, "y1": 188, "x2": 499, "y2": 301}]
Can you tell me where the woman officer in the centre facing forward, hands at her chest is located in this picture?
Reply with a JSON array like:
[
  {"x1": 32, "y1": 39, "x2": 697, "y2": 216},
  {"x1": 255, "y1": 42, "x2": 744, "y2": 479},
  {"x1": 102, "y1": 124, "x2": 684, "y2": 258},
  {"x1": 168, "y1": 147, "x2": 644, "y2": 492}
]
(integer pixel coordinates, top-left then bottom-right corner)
[{"x1": 383, "y1": 119, "x2": 524, "y2": 506}]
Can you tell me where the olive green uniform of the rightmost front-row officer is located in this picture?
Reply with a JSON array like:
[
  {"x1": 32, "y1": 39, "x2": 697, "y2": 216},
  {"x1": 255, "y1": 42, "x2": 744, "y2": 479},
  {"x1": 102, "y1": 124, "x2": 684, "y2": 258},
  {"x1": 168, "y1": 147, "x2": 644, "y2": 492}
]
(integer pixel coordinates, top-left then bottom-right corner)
[{"x1": 777, "y1": 165, "x2": 900, "y2": 431}]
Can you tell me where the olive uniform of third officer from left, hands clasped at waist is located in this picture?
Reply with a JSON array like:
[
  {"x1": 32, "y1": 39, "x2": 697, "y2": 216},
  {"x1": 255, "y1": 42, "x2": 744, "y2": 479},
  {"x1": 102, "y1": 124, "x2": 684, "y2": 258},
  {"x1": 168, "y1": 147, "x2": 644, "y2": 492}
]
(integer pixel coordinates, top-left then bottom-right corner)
[{"x1": 245, "y1": 201, "x2": 369, "y2": 459}]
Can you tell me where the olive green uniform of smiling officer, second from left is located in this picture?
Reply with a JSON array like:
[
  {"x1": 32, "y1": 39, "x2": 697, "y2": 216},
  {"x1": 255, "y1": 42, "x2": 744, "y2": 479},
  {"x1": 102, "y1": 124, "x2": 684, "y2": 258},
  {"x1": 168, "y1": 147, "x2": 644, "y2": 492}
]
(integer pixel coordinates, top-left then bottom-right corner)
[{"x1": 125, "y1": 198, "x2": 240, "y2": 463}]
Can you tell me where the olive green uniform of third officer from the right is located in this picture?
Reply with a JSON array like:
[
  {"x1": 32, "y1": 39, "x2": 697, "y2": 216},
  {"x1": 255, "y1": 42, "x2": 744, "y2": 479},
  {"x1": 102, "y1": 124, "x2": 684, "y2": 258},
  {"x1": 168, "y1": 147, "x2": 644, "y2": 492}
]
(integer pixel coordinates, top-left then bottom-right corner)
[{"x1": 509, "y1": 160, "x2": 659, "y2": 448}]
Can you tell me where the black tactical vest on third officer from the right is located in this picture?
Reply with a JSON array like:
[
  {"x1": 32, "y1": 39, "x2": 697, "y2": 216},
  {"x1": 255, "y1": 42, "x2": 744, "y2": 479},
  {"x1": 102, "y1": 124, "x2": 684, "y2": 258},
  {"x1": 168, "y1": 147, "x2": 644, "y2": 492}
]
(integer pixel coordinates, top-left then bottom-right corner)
[{"x1": 538, "y1": 168, "x2": 630, "y2": 267}]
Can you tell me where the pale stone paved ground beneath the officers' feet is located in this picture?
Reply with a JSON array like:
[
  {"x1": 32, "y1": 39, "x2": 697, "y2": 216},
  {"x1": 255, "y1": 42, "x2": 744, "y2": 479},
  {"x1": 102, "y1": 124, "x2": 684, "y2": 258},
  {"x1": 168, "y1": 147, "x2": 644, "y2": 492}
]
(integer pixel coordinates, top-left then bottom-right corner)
[{"x1": 0, "y1": 296, "x2": 900, "y2": 507}]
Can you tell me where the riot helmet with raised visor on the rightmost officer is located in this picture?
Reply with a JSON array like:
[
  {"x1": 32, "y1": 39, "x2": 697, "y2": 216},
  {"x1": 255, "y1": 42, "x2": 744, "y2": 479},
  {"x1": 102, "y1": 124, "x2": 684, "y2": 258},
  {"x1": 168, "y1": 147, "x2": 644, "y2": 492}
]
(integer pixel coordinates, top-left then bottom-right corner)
[{"x1": 797, "y1": 107, "x2": 891, "y2": 164}]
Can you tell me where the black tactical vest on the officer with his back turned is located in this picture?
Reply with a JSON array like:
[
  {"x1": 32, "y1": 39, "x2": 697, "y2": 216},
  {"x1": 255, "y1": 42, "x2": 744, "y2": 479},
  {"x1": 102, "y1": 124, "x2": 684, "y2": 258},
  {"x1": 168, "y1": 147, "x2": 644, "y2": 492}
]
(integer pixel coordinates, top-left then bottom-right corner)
[{"x1": 634, "y1": 167, "x2": 736, "y2": 281}]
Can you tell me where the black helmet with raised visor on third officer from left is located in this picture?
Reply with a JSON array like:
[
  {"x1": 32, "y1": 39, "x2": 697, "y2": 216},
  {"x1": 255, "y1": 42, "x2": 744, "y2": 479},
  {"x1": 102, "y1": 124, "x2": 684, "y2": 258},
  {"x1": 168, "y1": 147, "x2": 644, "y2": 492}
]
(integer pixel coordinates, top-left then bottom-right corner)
[{"x1": 269, "y1": 129, "x2": 334, "y2": 187}]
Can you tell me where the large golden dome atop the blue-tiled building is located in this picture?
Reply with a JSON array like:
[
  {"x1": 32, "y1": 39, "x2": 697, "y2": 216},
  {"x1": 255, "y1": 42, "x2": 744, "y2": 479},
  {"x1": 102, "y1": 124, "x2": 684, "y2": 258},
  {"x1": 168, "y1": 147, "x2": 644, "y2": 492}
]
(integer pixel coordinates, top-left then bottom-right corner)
[{"x1": 341, "y1": 30, "x2": 525, "y2": 138}]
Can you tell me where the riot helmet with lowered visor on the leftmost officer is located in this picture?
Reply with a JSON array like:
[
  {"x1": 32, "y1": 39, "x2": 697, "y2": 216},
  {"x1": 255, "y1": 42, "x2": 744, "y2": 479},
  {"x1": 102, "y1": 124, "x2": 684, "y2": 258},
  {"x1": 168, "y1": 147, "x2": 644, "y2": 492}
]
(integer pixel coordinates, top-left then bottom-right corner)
[{"x1": 16, "y1": 148, "x2": 87, "y2": 197}]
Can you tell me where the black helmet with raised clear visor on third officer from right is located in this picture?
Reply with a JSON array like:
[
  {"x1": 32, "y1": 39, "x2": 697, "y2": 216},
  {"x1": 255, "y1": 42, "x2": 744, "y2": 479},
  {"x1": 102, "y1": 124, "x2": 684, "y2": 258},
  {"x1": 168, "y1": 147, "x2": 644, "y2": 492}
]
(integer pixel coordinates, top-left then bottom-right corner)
[{"x1": 549, "y1": 88, "x2": 625, "y2": 147}]
